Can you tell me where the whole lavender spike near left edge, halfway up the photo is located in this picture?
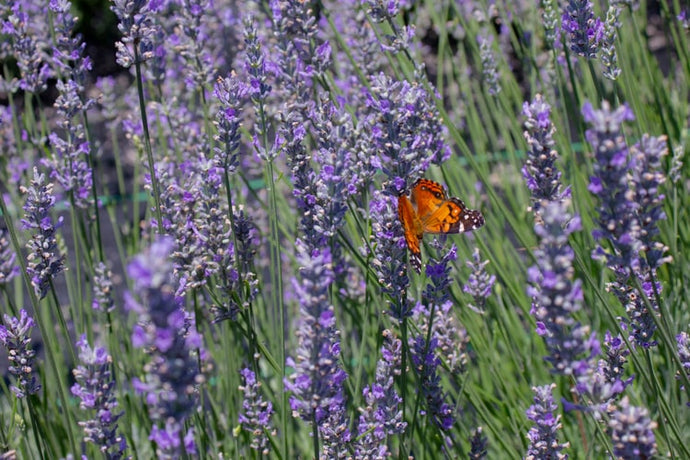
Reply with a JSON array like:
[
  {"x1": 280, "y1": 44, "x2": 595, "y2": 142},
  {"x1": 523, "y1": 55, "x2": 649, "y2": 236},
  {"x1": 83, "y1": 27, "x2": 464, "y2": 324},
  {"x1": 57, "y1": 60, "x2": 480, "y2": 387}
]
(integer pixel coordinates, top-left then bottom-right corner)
[{"x1": 21, "y1": 167, "x2": 65, "y2": 299}]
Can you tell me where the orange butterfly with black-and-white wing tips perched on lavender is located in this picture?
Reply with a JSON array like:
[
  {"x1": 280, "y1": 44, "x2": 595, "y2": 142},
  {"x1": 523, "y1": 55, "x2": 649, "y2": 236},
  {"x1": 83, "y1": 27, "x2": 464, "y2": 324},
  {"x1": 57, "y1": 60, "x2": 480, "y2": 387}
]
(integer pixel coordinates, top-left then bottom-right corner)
[{"x1": 398, "y1": 178, "x2": 484, "y2": 273}]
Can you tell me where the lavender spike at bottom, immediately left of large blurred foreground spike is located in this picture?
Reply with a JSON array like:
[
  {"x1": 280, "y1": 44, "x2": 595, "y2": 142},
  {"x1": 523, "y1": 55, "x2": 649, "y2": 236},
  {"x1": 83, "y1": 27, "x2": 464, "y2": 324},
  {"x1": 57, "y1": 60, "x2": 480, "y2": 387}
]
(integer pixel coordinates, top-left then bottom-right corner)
[{"x1": 70, "y1": 335, "x2": 127, "y2": 460}]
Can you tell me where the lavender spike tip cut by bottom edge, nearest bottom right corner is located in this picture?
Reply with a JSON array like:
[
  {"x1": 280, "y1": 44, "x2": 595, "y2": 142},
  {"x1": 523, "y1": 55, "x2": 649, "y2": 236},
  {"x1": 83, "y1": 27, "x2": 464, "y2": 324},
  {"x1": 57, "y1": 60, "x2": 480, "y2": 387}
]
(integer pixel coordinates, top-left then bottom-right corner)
[{"x1": 609, "y1": 396, "x2": 657, "y2": 459}]
